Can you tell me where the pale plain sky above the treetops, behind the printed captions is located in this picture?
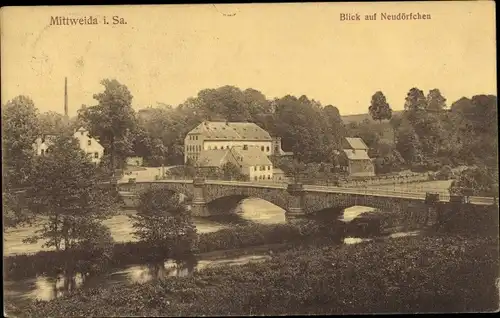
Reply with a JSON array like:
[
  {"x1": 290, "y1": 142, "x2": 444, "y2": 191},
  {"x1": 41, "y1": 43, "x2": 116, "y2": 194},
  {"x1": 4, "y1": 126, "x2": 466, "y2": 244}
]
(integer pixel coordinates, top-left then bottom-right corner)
[{"x1": 0, "y1": 1, "x2": 496, "y2": 116}]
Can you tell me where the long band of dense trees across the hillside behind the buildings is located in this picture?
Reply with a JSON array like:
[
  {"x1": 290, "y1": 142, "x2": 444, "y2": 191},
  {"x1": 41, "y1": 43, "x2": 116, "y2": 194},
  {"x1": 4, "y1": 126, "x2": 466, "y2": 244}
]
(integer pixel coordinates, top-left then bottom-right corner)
[{"x1": 2, "y1": 79, "x2": 498, "y2": 193}]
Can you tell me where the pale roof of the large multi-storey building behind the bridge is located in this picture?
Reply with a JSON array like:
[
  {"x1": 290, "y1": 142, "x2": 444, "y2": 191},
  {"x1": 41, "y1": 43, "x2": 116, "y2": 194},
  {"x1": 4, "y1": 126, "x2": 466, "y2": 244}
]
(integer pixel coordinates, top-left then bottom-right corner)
[{"x1": 189, "y1": 121, "x2": 272, "y2": 141}]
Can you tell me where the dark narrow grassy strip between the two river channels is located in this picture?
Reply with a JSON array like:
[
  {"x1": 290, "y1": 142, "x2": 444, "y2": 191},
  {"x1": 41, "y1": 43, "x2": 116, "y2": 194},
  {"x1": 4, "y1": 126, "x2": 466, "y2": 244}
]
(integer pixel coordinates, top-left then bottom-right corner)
[{"x1": 4, "y1": 223, "x2": 342, "y2": 280}]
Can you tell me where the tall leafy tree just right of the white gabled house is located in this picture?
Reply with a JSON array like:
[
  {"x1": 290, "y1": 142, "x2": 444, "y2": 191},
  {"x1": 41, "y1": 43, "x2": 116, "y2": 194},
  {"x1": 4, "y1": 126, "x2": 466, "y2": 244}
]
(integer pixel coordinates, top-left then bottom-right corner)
[{"x1": 79, "y1": 79, "x2": 136, "y2": 171}]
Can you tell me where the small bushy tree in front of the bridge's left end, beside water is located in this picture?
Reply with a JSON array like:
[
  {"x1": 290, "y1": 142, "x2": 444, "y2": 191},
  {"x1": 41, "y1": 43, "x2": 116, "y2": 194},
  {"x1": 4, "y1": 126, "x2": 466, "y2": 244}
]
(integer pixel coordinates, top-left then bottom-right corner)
[{"x1": 130, "y1": 188, "x2": 197, "y2": 256}]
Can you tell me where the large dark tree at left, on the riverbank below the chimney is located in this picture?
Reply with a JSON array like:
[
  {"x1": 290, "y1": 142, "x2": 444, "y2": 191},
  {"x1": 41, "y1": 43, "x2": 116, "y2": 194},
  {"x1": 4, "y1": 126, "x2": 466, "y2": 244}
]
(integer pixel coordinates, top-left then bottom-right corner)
[{"x1": 26, "y1": 132, "x2": 115, "y2": 251}]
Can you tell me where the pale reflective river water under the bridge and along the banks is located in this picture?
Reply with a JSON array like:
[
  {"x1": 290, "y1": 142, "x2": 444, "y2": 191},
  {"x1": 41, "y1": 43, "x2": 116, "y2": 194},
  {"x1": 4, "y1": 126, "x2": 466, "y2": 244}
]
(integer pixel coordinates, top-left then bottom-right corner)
[{"x1": 4, "y1": 199, "x2": 416, "y2": 304}]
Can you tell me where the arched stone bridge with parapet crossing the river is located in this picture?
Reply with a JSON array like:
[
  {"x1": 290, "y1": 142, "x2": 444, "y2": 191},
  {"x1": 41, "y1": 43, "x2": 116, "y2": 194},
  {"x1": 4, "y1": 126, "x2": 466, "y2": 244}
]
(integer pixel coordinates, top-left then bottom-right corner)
[{"x1": 118, "y1": 178, "x2": 492, "y2": 219}]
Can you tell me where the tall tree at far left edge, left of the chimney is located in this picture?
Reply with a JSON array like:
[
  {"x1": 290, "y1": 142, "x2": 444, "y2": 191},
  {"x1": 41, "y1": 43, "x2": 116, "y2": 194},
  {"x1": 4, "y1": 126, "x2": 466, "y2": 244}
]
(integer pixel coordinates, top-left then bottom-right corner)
[{"x1": 2, "y1": 95, "x2": 40, "y2": 188}]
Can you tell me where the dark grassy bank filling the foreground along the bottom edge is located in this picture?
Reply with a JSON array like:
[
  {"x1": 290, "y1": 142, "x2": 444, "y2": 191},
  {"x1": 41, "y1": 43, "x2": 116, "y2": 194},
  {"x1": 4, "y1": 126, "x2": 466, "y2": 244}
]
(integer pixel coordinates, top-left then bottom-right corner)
[{"x1": 7, "y1": 235, "x2": 499, "y2": 317}]
